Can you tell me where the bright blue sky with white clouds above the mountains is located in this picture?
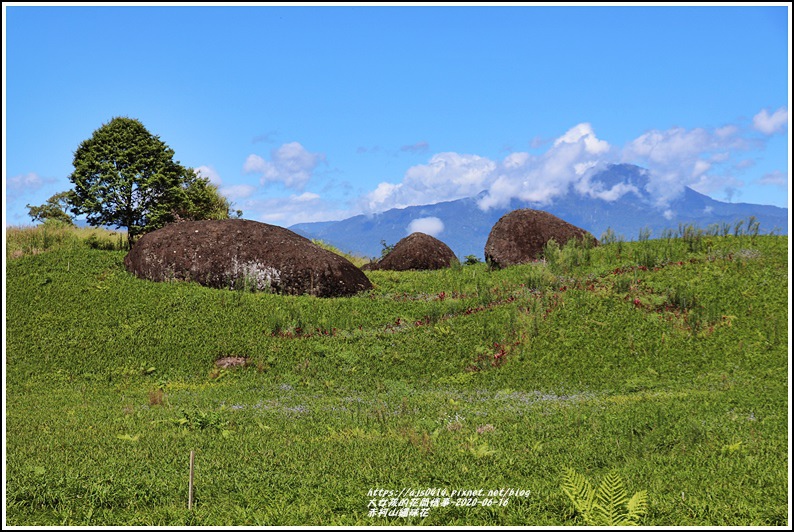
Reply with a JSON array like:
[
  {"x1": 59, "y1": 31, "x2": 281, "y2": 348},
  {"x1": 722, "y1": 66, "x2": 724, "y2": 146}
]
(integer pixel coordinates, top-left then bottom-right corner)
[{"x1": 3, "y1": 3, "x2": 791, "y2": 226}]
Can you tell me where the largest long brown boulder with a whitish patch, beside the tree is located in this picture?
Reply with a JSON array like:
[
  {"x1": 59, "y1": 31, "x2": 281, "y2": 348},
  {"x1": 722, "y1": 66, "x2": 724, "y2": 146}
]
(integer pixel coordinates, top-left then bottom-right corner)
[{"x1": 124, "y1": 219, "x2": 372, "y2": 297}]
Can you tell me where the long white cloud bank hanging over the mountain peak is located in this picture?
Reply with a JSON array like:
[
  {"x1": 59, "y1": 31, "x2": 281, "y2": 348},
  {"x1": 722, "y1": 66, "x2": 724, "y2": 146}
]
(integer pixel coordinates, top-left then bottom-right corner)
[{"x1": 350, "y1": 118, "x2": 787, "y2": 220}]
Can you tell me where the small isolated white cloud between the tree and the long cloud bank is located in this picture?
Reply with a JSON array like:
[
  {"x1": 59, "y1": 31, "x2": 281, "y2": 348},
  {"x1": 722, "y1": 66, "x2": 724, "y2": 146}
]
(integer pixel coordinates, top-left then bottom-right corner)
[{"x1": 243, "y1": 142, "x2": 325, "y2": 191}]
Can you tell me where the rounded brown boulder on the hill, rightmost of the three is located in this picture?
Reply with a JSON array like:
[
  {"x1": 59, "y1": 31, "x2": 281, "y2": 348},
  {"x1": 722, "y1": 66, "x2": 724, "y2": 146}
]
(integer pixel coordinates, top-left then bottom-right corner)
[{"x1": 485, "y1": 209, "x2": 598, "y2": 268}]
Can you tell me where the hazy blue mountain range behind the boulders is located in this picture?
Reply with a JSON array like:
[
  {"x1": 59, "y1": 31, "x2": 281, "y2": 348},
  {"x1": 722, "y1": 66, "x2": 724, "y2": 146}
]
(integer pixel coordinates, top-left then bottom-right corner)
[{"x1": 289, "y1": 164, "x2": 788, "y2": 260}]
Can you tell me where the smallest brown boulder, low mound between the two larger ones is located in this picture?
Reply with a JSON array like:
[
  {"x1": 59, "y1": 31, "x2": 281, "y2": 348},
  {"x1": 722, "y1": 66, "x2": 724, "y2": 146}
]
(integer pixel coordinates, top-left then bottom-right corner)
[{"x1": 366, "y1": 232, "x2": 458, "y2": 271}]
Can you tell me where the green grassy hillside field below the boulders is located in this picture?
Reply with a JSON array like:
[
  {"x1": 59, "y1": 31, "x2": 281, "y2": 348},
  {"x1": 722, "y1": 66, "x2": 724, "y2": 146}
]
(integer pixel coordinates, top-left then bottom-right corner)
[{"x1": 5, "y1": 223, "x2": 789, "y2": 526}]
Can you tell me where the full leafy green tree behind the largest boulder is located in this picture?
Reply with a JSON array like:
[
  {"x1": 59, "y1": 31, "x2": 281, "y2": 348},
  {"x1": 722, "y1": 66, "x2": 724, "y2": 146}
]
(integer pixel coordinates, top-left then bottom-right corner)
[{"x1": 69, "y1": 117, "x2": 229, "y2": 246}]
